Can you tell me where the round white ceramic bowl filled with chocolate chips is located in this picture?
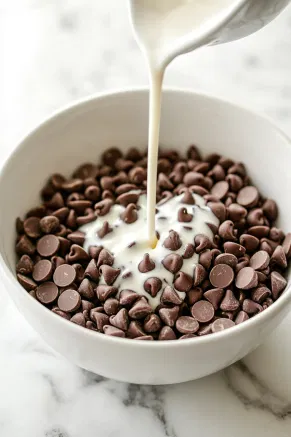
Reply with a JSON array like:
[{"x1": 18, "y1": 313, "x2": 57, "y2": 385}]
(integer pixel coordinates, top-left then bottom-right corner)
[{"x1": 0, "y1": 90, "x2": 291, "y2": 384}]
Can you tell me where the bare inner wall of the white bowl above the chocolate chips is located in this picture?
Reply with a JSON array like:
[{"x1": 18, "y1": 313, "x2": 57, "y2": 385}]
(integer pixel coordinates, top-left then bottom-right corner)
[{"x1": 0, "y1": 90, "x2": 291, "y2": 288}]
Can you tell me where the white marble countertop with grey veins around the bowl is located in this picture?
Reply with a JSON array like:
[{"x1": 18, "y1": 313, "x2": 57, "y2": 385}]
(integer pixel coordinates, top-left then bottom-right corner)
[{"x1": 0, "y1": 0, "x2": 291, "y2": 437}]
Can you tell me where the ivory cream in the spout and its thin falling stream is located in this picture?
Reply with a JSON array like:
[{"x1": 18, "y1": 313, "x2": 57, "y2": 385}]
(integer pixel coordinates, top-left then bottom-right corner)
[{"x1": 130, "y1": 0, "x2": 239, "y2": 247}]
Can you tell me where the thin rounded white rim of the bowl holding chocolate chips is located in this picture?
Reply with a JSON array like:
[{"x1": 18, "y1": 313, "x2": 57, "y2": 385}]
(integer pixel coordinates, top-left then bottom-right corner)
[{"x1": 0, "y1": 87, "x2": 291, "y2": 349}]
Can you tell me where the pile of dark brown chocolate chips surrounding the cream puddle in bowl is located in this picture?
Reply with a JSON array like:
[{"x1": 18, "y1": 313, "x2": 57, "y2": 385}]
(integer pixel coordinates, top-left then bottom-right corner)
[{"x1": 16, "y1": 146, "x2": 291, "y2": 340}]
